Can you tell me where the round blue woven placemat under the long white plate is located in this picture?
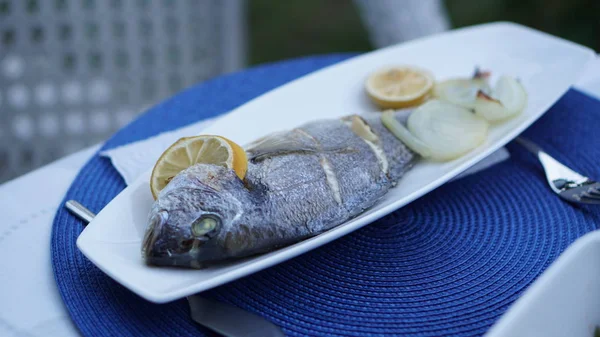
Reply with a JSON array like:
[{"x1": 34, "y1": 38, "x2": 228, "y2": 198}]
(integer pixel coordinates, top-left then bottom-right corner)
[{"x1": 52, "y1": 55, "x2": 600, "y2": 336}]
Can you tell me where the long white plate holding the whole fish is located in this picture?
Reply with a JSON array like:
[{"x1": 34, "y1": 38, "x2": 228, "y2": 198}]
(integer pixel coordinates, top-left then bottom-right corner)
[{"x1": 77, "y1": 23, "x2": 594, "y2": 302}]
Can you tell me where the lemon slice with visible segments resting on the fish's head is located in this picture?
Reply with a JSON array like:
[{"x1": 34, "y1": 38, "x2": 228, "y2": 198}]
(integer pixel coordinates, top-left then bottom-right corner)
[{"x1": 150, "y1": 136, "x2": 248, "y2": 199}]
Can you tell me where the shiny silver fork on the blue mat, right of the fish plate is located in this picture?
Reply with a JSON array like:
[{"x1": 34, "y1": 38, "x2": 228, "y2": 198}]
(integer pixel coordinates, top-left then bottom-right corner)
[{"x1": 515, "y1": 137, "x2": 600, "y2": 205}]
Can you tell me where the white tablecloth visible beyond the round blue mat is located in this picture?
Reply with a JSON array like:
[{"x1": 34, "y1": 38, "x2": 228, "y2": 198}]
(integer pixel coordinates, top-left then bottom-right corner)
[{"x1": 0, "y1": 57, "x2": 600, "y2": 337}]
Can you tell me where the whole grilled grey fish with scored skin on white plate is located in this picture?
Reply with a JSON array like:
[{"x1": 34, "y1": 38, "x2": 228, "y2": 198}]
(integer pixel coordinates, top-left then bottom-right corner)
[{"x1": 142, "y1": 113, "x2": 416, "y2": 268}]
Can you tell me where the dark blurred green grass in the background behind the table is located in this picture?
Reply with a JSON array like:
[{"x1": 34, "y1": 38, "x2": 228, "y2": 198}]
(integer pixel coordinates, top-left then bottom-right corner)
[{"x1": 248, "y1": 0, "x2": 600, "y2": 64}]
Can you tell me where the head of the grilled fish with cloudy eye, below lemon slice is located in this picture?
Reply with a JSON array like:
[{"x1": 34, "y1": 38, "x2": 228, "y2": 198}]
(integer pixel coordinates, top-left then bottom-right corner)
[{"x1": 142, "y1": 164, "x2": 251, "y2": 268}]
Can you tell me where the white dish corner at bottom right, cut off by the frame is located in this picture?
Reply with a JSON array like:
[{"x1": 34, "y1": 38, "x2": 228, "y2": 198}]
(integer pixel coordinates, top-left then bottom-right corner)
[{"x1": 486, "y1": 230, "x2": 600, "y2": 337}]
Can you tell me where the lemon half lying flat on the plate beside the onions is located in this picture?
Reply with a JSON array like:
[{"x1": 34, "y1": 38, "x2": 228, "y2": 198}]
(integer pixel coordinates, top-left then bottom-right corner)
[{"x1": 365, "y1": 66, "x2": 434, "y2": 109}]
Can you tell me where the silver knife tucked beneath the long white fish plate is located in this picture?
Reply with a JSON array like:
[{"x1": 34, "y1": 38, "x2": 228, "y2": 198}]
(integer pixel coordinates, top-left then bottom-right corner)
[{"x1": 65, "y1": 200, "x2": 285, "y2": 337}]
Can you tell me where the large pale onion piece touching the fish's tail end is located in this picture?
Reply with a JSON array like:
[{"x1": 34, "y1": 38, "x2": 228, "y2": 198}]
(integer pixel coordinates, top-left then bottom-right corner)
[{"x1": 382, "y1": 100, "x2": 489, "y2": 161}]
